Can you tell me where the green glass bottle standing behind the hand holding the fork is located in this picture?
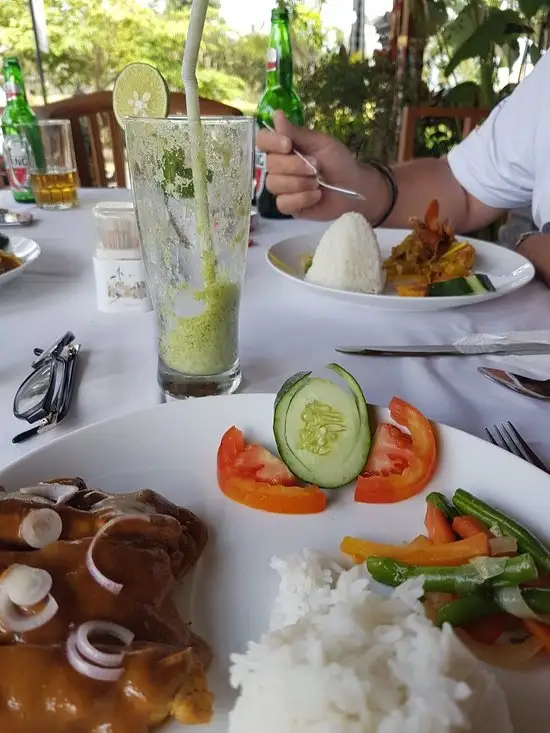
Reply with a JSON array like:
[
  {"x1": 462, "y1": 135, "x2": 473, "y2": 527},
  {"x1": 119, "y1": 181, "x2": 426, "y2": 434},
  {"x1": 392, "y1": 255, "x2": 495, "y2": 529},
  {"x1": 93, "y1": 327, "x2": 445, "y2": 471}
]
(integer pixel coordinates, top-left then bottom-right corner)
[{"x1": 256, "y1": 3, "x2": 304, "y2": 219}]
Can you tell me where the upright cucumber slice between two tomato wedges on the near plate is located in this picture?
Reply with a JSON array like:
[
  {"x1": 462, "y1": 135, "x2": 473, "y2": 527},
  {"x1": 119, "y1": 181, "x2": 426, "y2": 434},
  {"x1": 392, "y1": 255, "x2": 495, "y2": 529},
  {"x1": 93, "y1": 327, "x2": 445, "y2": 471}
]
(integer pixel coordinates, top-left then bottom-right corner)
[{"x1": 273, "y1": 364, "x2": 371, "y2": 489}]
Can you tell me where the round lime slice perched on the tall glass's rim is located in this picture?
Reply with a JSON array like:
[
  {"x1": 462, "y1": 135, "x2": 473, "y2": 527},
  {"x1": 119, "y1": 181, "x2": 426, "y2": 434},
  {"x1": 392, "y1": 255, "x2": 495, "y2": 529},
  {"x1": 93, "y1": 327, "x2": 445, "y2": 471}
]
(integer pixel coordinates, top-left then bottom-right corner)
[{"x1": 113, "y1": 62, "x2": 170, "y2": 129}]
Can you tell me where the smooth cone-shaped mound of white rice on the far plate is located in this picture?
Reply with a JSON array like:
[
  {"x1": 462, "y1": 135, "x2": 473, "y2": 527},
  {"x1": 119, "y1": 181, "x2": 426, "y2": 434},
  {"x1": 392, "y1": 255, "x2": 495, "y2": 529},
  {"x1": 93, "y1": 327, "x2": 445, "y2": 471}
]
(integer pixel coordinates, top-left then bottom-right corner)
[{"x1": 305, "y1": 212, "x2": 386, "y2": 293}]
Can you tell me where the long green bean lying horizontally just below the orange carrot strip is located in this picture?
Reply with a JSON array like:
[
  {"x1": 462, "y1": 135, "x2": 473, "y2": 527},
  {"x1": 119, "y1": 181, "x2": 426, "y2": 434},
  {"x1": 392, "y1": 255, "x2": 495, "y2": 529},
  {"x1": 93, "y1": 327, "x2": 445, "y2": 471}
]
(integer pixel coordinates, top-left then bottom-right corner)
[{"x1": 367, "y1": 554, "x2": 538, "y2": 595}]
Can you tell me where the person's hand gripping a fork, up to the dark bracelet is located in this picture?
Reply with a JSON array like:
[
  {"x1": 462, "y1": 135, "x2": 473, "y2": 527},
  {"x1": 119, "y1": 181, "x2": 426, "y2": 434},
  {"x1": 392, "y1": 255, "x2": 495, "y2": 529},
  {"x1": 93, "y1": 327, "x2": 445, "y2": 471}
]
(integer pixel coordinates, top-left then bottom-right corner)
[{"x1": 256, "y1": 111, "x2": 370, "y2": 221}]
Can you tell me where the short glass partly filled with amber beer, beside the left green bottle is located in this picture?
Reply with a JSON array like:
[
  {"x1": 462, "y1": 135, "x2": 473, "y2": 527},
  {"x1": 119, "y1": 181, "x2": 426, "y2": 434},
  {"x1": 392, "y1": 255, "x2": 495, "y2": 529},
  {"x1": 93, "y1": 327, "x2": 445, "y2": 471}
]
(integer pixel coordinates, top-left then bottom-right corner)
[{"x1": 20, "y1": 120, "x2": 79, "y2": 209}]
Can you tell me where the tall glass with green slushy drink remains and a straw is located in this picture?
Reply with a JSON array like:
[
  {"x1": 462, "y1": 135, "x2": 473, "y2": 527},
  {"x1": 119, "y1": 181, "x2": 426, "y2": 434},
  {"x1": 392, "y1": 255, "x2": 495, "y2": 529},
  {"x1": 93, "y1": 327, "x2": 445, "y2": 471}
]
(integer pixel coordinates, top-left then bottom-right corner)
[{"x1": 125, "y1": 117, "x2": 254, "y2": 398}]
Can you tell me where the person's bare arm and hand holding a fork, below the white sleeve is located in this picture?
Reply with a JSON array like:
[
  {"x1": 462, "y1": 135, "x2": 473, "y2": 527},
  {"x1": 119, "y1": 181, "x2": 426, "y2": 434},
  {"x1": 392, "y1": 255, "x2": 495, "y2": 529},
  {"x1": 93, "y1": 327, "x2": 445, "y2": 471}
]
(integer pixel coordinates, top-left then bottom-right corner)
[{"x1": 264, "y1": 118, "x2": 500, "y2": 231}]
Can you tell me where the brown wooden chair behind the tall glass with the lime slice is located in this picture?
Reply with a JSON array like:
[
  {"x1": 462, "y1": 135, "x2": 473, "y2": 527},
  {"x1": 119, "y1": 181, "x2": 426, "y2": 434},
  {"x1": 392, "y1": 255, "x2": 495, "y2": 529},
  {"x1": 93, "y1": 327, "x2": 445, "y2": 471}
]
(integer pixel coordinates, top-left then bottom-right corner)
[{"x1": 34, "y1": 92, "x2": 242, "y2": 188}]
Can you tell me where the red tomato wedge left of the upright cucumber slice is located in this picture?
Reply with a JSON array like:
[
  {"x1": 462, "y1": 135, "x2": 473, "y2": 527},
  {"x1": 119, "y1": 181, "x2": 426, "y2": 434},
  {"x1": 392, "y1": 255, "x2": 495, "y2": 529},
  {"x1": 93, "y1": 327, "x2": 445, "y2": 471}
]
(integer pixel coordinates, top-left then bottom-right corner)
[{"x1": 218, "y1": 426, "x2": 327, "y2": 514}]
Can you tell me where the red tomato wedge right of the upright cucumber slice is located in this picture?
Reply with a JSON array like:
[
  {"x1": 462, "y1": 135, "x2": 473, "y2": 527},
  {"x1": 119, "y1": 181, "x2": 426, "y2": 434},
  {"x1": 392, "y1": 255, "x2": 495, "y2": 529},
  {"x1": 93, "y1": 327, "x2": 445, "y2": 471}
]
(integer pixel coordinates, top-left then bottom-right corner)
[{"x1": 355, "y1": 397, "x2": 437, "y2": 504}]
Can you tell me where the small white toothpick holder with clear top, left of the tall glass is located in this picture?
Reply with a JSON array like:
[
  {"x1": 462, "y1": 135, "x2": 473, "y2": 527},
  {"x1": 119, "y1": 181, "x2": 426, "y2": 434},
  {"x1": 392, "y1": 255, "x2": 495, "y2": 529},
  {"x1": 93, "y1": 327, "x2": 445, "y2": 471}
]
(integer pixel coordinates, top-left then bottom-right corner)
[{"x1": 93, "y1": 202, "x2": 153, "y2": 313}]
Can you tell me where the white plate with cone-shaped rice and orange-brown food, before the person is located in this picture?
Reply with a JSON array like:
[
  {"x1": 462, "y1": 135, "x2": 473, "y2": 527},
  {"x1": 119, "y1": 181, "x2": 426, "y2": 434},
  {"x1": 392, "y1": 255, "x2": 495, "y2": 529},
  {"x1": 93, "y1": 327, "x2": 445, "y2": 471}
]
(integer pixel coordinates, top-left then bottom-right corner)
[{"x1": 267, "y1": 200, "x2": 535, "y2": 312}]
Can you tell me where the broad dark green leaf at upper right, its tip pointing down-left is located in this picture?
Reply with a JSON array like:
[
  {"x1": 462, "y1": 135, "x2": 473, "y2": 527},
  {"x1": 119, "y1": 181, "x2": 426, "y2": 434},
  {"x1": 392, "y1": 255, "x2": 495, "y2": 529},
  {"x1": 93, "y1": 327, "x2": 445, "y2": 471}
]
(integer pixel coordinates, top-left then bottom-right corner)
[{"x1": 445, "y1": 8, "x2": 533, "y2": 76}]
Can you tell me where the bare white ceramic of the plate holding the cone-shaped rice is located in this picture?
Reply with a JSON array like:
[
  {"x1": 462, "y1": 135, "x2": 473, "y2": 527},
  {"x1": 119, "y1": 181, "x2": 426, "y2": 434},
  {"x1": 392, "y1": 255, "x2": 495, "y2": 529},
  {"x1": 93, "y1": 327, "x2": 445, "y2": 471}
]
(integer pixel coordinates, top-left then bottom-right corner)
[{"x1": 266, "y1": 229, "x2": 535, "y2": 311}]
